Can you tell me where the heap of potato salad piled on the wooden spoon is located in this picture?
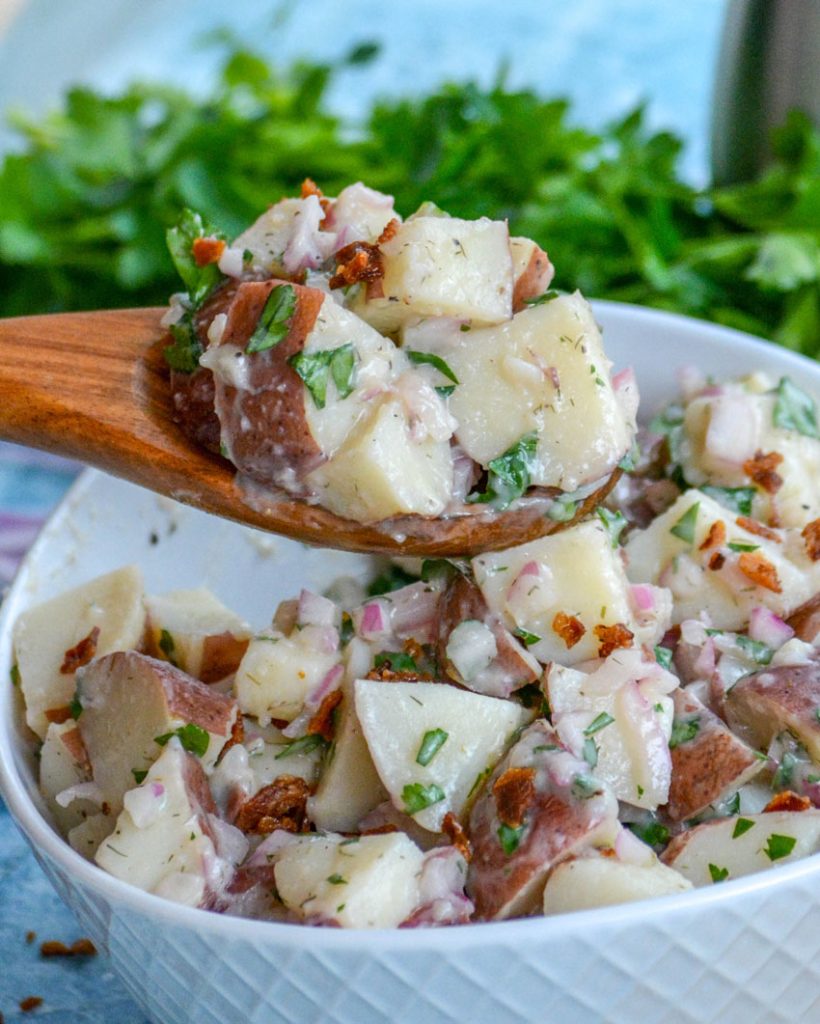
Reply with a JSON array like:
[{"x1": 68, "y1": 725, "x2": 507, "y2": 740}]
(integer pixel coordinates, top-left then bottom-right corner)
[{"x1": 159, "y1": 181, "x2": 638, "y2": 532}]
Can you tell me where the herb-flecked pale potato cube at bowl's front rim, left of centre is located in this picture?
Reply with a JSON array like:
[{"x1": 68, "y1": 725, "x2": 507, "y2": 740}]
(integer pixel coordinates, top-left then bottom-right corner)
[{"x1": 274, "y1": 833, "x2": 424, "y2": 928}]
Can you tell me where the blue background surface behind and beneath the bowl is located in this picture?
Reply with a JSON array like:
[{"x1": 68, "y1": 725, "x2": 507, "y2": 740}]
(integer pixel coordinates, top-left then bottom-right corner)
[{"x1": 0, "y1": 0, "x2": 724, "y2": 1024}]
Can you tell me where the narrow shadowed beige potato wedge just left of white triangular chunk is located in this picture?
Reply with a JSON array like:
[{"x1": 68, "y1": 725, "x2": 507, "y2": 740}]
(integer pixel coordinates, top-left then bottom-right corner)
[{"x1": 307, "y1": 685, "x2": 389, "y2": 833}]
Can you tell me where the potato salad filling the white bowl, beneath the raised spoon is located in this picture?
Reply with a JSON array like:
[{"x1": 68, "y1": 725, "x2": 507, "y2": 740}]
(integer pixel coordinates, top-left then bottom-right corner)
[{"x1": 12, "y1": 368, "x2": 820, "y2": 928}]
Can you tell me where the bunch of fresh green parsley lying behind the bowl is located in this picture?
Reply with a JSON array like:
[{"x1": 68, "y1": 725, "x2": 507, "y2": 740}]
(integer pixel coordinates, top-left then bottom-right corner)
[{"x1": 0, "y1": 44, "x2": 820, "y2": 355}]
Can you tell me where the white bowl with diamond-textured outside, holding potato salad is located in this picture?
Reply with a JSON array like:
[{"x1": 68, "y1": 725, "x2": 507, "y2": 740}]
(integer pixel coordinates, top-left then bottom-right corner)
[{"x1": 0, "y1": 303, "x2": 820, "y2": 1024}]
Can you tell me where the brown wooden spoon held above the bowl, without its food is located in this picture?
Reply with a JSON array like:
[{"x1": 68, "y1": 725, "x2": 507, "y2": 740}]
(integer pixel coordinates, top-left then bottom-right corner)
[{"x1": 0, "y1": 309, "x2": 619, "y2": 557}]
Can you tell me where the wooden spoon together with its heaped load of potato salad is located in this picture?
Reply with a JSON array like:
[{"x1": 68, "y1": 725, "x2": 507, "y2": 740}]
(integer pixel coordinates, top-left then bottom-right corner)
[{"x1": 0, "y1": 181, "x2": 638, "y2": 556}]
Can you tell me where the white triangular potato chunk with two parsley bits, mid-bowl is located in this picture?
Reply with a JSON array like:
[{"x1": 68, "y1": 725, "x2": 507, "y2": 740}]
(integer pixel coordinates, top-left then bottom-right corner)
[{"x1": 354, "y1": 679, "x2": 528, "y2": 831}]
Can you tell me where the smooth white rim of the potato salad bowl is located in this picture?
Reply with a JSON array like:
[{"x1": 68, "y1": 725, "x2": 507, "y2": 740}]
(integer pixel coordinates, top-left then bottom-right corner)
[{"x1": 0, "y1": 301, "x2": 820, "y2": 953}]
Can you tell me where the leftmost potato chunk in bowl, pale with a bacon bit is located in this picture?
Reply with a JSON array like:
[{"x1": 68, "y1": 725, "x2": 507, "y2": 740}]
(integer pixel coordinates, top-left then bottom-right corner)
[{"x1": 14, "y1": 565, "x2": 145, "y2": 739}]
